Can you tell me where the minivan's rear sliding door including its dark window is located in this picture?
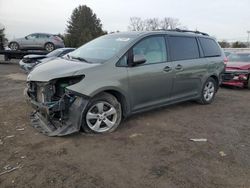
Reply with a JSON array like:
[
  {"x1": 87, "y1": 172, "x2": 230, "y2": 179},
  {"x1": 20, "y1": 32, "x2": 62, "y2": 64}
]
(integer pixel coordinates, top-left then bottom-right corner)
[{"x1": 168, "y1": 36, "x2": 207, "y2": 100}]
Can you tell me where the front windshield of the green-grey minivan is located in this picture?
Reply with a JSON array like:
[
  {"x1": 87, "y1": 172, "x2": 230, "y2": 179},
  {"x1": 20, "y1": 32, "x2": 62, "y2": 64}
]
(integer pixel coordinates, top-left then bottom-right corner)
[{"x1": 70, "y1": 35, "x2": 135, "y2": 63}]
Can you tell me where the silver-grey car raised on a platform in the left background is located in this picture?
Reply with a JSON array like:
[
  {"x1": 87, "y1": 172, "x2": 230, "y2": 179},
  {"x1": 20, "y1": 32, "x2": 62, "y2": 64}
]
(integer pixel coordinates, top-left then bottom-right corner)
[{"x1": 8, "y1": 33, "x2": 64, "y2": 52}]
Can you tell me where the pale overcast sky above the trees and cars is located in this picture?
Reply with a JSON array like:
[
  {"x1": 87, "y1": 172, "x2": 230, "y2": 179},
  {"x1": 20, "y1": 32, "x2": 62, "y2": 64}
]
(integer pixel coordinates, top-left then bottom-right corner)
[{"x1": 0, "y1": 0, "x2": 250, "y2": 41}]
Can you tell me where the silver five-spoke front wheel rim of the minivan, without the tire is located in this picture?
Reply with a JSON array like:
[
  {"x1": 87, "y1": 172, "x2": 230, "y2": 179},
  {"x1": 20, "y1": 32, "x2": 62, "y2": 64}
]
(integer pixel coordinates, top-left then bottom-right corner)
[{"x1": 86, "y1": 102, "x2": 117, "y2": 133}]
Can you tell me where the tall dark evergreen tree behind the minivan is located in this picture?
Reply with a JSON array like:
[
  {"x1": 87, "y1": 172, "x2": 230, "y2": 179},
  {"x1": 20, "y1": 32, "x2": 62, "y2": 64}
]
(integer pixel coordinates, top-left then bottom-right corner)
[{"x1": 64, "y1": 5, "x2": 105, "y2": 47}]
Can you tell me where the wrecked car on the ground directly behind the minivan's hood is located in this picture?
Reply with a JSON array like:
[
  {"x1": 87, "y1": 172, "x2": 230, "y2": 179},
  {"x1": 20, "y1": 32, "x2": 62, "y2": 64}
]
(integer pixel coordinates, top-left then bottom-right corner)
[{"x1": 19, "y1": 48, "x2": 75, "y2": 72}]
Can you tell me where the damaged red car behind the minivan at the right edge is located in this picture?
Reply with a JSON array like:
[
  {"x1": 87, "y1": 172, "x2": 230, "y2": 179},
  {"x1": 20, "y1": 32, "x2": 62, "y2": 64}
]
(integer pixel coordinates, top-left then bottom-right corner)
[{"x1": 222, "y1": 52, "x2": 250, "y2": 88}]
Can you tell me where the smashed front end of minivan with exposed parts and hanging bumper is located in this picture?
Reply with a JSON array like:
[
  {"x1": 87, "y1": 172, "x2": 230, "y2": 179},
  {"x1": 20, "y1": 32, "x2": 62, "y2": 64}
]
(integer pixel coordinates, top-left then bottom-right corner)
[{"x1": 25, "y1": 76, "x2": 88, "y2": 136}]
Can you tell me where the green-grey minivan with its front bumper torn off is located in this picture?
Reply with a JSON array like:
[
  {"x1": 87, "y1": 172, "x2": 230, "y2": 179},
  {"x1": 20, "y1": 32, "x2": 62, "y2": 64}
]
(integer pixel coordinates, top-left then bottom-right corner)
[{"x1": 25, "y1": 30, "x2": 225, "y2": 136}]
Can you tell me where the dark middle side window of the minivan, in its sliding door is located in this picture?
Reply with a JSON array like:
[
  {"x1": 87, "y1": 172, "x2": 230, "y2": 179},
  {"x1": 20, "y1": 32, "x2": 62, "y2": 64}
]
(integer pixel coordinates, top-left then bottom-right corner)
[{"x1": 169, "y1": 36, "x2": 200, "y2": 61}]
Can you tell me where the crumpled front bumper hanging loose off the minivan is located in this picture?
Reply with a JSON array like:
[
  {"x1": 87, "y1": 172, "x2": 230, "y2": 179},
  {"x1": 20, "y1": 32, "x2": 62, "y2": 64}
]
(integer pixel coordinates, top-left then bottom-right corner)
[{"x1": 24, "y1": 89, "x2": 88, "y2": 136}]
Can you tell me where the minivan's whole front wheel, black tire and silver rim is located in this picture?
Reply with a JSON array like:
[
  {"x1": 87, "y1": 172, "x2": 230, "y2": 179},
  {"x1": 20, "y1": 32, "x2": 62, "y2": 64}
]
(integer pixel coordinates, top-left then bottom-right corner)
[{"x1": 82, "y1": 93, "x2": 122, "y2": 134}]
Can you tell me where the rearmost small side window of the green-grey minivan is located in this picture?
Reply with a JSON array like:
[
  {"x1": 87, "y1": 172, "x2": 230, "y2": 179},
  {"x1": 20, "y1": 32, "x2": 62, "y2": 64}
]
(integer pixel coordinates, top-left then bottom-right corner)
[{"x1": 199, "y1": 38, "x2": 221, "y2": 57}]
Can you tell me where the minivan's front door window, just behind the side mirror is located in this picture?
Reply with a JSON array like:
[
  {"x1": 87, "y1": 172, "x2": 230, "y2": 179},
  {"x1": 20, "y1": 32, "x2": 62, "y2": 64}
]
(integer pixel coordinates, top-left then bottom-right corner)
[{"x1": 133, "y1": 36, "x2": 167, "y2": 64}]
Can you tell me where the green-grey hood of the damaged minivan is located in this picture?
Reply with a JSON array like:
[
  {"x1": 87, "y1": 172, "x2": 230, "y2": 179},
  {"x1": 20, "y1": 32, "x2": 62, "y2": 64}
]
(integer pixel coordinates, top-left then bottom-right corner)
[{"x1": 27, "y1": 58, "x2": 100, "y2": 82}]
